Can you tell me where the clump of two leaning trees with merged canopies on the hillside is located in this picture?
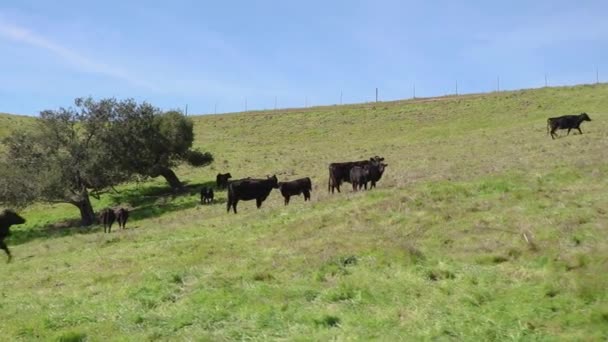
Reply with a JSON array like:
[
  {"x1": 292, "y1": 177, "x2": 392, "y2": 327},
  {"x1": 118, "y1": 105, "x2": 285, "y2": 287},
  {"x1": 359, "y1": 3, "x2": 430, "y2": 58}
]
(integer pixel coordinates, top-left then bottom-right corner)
[{"x1": 0, "y1": 98, "x2": 213, "y2": 225}]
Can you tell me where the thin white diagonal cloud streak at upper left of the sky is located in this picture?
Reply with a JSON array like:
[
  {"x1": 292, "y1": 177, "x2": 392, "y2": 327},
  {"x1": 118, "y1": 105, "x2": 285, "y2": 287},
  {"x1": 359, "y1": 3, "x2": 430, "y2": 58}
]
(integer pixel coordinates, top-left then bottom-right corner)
[{"x1": 0, "y1": 18, "x2": 156, "y2": 90}]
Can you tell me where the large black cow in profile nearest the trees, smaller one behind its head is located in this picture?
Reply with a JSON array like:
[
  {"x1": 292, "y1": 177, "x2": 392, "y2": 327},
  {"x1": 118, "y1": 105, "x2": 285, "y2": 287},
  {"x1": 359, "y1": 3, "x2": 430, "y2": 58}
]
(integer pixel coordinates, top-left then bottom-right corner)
[{"x1": 226, "y1": 175, "x2": 279, "y2": 214}]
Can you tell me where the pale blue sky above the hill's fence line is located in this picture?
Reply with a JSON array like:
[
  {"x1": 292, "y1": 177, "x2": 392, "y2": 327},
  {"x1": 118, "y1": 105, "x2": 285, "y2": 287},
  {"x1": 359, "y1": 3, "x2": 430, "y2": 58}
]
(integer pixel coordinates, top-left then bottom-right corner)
[{"x1": 0, "y1": 0, "x2": 608, "y2": 115}]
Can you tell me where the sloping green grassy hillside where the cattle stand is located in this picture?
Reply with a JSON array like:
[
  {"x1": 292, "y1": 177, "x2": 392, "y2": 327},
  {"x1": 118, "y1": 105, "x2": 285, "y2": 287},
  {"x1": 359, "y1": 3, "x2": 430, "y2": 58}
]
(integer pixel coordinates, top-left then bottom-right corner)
[{"x1": 0, "y1": 85, "x2": 608, "y2": 340}]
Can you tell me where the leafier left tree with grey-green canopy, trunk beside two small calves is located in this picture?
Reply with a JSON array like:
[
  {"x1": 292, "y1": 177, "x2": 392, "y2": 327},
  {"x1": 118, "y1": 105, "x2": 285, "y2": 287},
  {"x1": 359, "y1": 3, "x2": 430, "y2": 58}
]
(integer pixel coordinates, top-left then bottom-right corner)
[{"x1": 0, "y1": 99, "x2": 130, "y2": 226}]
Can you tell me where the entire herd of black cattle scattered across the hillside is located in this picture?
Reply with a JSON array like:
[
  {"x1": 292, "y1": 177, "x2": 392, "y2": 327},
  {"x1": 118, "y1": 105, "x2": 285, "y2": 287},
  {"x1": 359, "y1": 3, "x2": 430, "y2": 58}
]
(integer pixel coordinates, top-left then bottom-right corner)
[{"x1": 0, "y1": 113, "x2": 591, "y2": 262}]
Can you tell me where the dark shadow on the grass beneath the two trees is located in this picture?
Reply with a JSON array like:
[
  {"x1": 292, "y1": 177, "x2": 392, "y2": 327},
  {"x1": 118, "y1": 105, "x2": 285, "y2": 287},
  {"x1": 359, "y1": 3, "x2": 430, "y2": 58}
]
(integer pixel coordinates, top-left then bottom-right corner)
[{"x1": 7, "y1": 182, "x2": 225, "y2": 246}]
